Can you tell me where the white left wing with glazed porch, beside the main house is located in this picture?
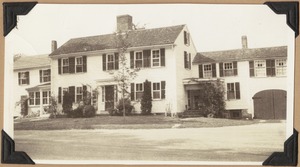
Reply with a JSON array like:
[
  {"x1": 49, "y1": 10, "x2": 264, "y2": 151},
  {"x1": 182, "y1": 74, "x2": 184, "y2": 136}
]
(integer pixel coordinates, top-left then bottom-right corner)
[{"x1": 14, "y1": 55, "x2": 51, "y2": 116}]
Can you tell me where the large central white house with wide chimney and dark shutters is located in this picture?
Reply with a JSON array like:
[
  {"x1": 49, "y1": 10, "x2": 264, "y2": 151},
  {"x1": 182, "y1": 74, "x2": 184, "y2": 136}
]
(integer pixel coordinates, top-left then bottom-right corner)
[{"x1": 50, "y1": 15, "x2": 197, "y2": 114}]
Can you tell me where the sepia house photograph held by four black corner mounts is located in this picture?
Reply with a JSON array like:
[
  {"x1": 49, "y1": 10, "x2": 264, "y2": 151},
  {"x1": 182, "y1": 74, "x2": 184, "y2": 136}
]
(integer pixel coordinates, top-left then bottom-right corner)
[{"x1": 4, "y1": 3, "x2": 295, "y2": 165}]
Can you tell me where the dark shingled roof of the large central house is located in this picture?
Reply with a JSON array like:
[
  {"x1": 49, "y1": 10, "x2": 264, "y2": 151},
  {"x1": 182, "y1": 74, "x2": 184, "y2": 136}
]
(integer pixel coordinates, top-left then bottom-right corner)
[{"x1": 50, "y1": 25, "x2": 185, "y2": 56}]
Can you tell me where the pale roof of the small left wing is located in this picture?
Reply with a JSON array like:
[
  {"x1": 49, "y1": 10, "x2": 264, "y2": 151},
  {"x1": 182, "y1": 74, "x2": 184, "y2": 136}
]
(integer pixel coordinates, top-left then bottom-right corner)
[{"x1": 14, "y1": 54, "x2": 51, "y2": 70}]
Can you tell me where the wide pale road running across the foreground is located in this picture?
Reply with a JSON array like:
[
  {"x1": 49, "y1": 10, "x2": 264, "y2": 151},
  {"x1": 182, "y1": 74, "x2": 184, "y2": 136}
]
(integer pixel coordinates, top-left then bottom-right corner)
[{"x1": 15, "y1": 123, "x2": 285, "y2": 161}]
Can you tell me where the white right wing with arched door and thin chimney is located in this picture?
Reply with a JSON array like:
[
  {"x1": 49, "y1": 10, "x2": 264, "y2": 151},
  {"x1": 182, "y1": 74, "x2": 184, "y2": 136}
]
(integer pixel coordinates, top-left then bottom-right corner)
[{"x1": 184, "y1": 36, "x2": 287, "y2": 119}]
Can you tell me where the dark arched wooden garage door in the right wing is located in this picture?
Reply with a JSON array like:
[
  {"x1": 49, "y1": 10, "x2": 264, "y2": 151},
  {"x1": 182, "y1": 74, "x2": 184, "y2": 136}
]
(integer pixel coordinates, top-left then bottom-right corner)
[{"x1": 253, "y1": 89, "x2": 286, "y2": 119}]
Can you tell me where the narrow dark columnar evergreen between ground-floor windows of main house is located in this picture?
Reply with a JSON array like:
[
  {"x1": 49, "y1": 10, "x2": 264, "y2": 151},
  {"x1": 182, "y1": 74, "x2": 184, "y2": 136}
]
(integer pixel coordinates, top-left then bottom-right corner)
[{"x1": 141, "y1": 80, "x2": 152, "y2": 115}]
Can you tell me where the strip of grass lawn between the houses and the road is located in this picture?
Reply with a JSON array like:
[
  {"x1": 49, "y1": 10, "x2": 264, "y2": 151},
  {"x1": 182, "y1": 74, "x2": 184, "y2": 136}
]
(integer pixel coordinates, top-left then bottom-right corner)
[{"x1": 14, "y1": 115, "x2": 276, "y2": 130}]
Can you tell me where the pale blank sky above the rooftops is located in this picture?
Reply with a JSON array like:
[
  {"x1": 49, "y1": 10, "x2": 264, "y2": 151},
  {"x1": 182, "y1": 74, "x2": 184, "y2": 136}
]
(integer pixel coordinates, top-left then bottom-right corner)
[{"x1": 5, "y1": 4, "x2": 292, "y2": 56}]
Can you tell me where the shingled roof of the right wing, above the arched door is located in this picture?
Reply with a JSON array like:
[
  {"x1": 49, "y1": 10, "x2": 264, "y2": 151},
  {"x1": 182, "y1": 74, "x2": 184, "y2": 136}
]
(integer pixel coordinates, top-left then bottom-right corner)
[{"x1": 193, "y1": 46, "x2": 287, "y2": 64}]
